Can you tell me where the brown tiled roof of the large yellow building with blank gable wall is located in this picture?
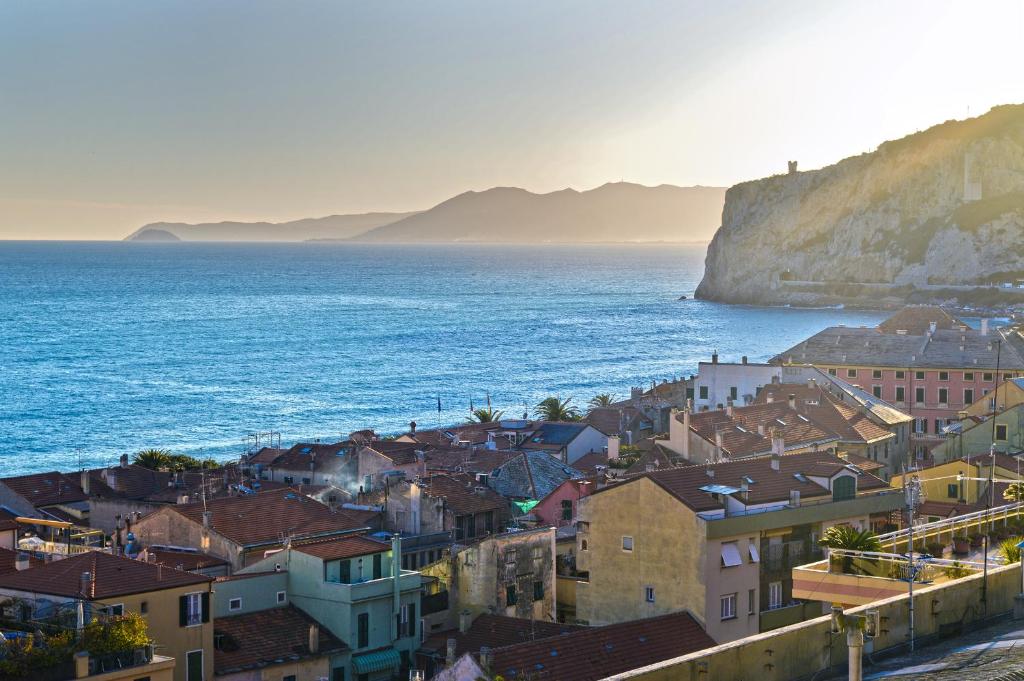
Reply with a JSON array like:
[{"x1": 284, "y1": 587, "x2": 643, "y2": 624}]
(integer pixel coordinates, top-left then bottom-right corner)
[{"x1": 591, "y1": 452, "x2": 889, "y2": 512}]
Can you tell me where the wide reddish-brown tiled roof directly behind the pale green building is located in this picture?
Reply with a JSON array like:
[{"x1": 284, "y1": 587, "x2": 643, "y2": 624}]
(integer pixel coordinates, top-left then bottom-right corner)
[{"x1": 168, "y1": 487, "x2": 377, "y2": 546}]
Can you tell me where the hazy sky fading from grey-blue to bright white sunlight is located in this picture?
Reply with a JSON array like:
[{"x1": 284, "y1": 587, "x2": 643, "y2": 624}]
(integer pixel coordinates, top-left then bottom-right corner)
[{"x1": 0, "y1": 0, "x2": 1024, "y2": 239}]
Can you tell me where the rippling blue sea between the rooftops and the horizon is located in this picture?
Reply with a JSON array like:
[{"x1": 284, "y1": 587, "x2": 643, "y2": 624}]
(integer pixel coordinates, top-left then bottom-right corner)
[{"x1": 0, "y1": 242, "x2": 882, "y2": 475}]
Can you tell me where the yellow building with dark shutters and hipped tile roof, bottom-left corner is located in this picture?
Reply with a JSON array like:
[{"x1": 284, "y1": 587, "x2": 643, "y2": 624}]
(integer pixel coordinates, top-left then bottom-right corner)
[{"x1": 0, "y1": 551, "x2": 213, "y2": 681}]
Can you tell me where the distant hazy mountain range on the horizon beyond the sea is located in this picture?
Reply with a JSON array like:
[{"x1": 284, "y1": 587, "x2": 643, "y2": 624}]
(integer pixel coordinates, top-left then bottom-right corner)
[{"x1": 127, "y1": 182, "x2": 725, "y2": 244}]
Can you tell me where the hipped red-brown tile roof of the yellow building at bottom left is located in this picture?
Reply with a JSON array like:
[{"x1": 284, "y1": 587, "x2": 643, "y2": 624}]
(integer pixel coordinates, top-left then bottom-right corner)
[{"x1": 0, "y1": 551, "x2": 213, "y2": 600}]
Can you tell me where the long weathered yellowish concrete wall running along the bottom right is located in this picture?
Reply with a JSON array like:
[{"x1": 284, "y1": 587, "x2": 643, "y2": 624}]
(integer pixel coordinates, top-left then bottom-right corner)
[{"x1": 607, "y1": 564, "x2": 1021, "y2": 681}]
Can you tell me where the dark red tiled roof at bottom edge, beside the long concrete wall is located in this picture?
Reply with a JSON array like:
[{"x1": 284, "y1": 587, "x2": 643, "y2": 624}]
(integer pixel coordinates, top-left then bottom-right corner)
[{"x1": 490, "y1": 612, "x2": 715, "y2": 681}]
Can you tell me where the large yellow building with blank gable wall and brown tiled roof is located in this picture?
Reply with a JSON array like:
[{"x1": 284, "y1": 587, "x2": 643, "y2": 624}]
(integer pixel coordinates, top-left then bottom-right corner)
[{"x1": 575, "y1": 453, "x2": 902, "y2": 642}]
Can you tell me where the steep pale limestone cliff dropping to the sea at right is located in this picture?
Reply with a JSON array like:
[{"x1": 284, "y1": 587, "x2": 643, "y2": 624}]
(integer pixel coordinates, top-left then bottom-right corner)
[{"x1": 696, "y1": 105, "x2": 1024, "y2": 304}]
